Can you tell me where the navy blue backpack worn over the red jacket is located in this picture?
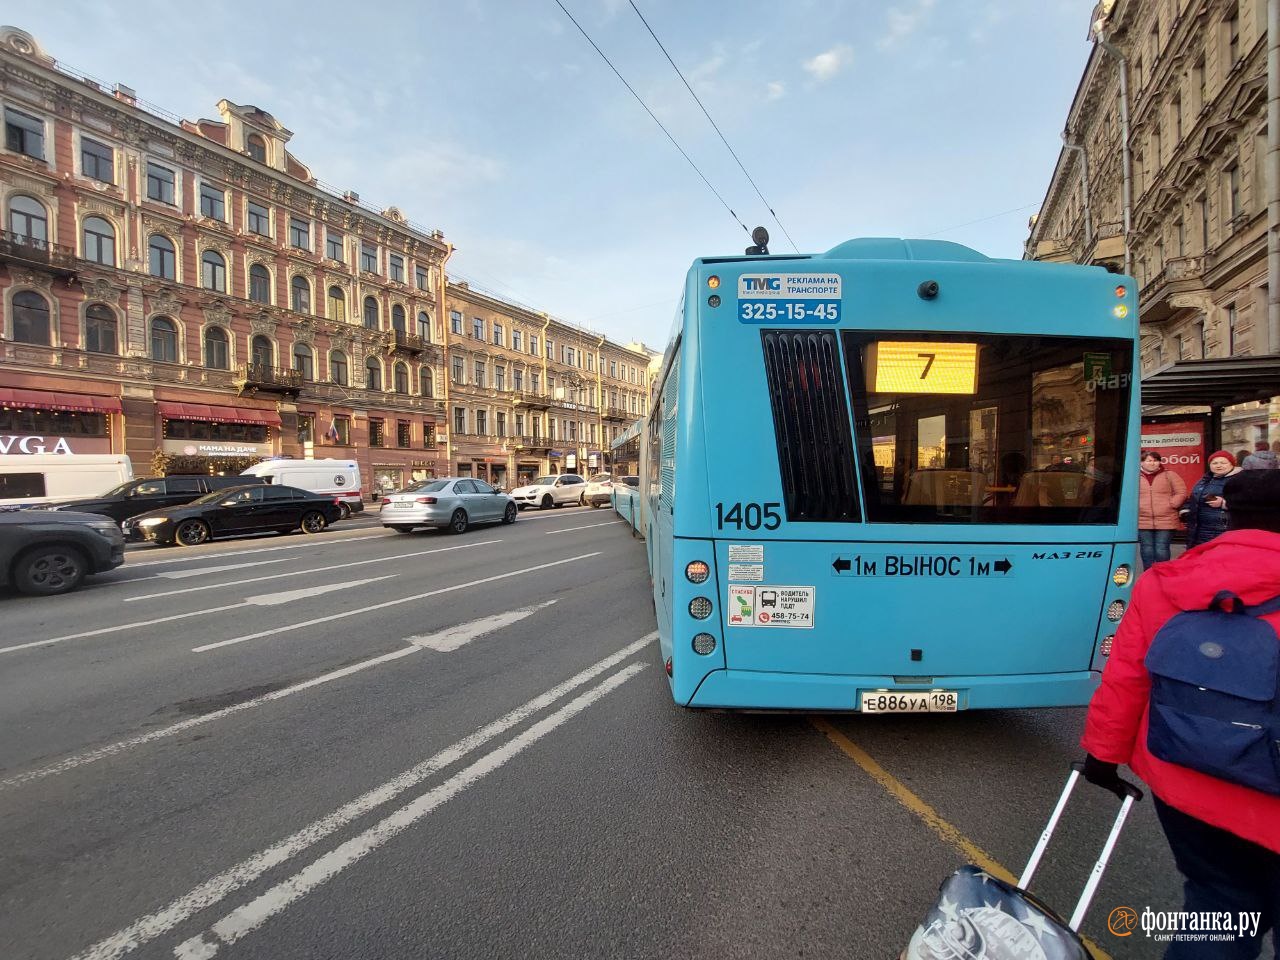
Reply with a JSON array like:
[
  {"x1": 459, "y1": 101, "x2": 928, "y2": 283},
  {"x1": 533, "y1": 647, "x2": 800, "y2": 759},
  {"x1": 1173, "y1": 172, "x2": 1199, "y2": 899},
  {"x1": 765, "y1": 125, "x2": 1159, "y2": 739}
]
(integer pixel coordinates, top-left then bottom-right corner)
[{"x1": 1144, "y1": 590, "x2": 1280, "y2": 795}]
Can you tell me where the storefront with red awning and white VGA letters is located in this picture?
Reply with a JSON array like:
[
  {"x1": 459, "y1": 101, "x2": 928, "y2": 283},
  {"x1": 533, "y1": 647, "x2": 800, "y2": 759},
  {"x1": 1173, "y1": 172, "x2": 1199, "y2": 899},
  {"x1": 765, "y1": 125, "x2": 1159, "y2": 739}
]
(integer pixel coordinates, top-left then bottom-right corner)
[{"x1": 0, "y1": 387, "x2": 120, "y2": 456}]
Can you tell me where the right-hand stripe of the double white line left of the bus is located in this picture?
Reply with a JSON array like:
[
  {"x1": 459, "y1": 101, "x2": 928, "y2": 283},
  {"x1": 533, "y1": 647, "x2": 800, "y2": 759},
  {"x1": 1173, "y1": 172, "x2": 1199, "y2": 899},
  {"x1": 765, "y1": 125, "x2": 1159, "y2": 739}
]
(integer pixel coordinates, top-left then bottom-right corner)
[{"x1": 173, "y1": 663, "x2": 645, "y2": 960}]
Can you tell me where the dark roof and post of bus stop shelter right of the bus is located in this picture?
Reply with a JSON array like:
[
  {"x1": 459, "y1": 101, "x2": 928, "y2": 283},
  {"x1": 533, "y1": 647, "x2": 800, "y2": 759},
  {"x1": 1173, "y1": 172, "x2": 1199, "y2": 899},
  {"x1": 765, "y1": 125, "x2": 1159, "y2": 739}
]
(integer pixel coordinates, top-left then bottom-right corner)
[{"x1": 1142, "y1": 355, "x2": 1280, "y2": 449}]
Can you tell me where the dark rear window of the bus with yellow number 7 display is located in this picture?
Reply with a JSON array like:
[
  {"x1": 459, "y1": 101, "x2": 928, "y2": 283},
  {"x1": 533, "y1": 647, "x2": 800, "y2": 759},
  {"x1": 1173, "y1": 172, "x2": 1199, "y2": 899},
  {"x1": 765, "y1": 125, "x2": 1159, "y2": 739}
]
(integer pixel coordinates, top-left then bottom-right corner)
[{"x1": 844, "y1": 330, "x2": 1133, "y2": 524}]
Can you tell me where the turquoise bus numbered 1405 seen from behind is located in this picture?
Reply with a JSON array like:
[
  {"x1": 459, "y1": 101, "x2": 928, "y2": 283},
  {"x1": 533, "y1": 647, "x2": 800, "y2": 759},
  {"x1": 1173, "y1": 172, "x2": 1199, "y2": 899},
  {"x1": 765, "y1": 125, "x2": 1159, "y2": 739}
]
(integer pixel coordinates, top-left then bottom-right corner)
[{"x1": 636, "y1": 238, "x2": 1139, "y2": 713}]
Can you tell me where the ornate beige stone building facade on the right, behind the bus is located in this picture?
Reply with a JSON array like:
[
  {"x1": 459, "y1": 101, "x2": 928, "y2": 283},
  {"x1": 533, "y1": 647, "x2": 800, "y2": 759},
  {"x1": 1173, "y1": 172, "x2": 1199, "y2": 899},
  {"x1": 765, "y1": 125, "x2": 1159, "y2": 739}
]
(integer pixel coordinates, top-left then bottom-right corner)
[{"x1": 1027, "y1": 0, "x2": 1280, "y2": 449}]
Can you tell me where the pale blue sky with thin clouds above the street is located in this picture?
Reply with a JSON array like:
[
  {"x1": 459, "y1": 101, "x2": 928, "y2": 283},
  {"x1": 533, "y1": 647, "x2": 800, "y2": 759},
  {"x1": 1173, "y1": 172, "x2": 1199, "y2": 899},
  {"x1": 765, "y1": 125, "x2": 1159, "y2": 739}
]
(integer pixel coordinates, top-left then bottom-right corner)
[{"x1": 17, "y1": 0, "x2": 1093, "y2": 347}]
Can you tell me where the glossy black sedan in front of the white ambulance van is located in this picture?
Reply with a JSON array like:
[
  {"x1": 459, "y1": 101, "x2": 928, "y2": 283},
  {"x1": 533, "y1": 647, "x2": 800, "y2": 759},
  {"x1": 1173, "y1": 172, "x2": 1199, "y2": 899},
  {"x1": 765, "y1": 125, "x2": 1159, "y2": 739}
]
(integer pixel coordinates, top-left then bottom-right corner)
[{"x1": 124, "y1": 484, "x2": 342, "y2": 547}]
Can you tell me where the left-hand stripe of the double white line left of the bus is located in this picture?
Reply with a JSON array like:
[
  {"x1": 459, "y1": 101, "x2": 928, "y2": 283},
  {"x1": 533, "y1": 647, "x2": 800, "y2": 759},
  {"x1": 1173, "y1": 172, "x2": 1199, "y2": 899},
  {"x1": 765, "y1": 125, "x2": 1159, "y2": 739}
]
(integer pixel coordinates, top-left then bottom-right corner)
[{"x1": 63, "y1": 634, "x2": 658, "y2": 960}]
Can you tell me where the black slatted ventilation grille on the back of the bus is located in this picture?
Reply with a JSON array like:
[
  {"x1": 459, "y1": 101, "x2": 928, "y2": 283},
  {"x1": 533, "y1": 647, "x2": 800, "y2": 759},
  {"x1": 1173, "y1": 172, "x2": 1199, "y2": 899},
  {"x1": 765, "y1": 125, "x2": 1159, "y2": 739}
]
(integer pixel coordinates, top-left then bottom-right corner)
[{"x1": 762, "y1": 330, "x2": 859, "y2": 522}]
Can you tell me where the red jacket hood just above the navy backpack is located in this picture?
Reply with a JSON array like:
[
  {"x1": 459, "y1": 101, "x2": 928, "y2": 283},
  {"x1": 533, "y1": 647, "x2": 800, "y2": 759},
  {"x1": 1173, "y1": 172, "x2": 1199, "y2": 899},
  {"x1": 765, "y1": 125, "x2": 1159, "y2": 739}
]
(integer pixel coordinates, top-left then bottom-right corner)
[{"x1": 1144, "y1": 530, "x2": 1280, "y2": 611}]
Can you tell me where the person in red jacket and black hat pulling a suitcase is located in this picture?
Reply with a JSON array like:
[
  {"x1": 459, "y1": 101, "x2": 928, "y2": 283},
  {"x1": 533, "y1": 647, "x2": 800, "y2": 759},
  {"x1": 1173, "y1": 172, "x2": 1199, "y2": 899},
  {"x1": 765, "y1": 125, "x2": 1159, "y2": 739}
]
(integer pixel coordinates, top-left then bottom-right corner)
[{"x1": 1080, "y1": 470, "x2": 1280, "y2": 960}]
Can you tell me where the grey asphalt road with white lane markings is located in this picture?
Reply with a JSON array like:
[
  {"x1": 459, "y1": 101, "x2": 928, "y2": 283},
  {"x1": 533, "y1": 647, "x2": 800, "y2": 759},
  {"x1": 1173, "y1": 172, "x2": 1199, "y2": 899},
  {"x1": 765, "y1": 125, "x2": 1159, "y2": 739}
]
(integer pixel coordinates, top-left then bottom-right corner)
[{"x1": 0, "y1": 508, "x2": 1218, "y2": 960}]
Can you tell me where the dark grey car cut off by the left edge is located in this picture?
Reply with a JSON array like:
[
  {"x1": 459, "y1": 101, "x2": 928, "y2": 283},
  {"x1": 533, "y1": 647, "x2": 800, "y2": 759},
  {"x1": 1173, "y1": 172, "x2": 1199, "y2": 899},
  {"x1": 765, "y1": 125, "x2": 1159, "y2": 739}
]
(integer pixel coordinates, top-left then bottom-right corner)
[{"x1": 0, "y1": 511, "x2": 124, "y2": 596}]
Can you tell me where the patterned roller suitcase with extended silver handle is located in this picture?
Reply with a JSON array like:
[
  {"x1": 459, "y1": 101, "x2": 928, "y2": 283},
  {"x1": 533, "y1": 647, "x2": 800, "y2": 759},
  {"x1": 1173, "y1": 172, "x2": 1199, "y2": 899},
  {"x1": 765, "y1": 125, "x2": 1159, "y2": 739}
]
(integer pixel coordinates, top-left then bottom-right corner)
[{"x1": 901, "y1": 763, "x2": 1142, "y2": 960}]
